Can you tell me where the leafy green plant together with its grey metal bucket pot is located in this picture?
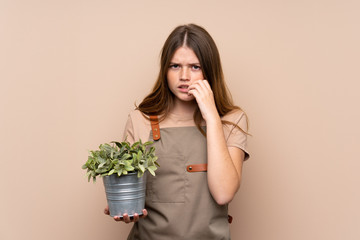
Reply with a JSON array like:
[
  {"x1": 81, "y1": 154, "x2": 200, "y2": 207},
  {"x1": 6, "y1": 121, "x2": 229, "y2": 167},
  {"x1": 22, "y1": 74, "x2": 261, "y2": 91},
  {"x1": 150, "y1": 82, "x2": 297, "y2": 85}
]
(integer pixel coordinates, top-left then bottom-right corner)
[{"x1": 82, "y1": 140, "x2": 159, "y2": 217}]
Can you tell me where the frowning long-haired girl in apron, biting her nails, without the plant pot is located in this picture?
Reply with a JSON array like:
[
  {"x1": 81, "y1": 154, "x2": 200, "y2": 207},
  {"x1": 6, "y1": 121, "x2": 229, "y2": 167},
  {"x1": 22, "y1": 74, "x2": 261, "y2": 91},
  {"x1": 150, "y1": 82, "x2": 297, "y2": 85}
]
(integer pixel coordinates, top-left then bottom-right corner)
[{"x1": 105, "y1": 24, "x2": 249, "y2": 240}]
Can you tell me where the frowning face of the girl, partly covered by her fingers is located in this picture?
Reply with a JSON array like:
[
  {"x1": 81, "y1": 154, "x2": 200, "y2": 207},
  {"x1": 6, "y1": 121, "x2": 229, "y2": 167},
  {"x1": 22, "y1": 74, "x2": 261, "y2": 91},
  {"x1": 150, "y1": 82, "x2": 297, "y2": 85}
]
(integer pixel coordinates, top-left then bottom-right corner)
[{"x1": 167, "y1": 47, "x2": 204, "y2": 101}]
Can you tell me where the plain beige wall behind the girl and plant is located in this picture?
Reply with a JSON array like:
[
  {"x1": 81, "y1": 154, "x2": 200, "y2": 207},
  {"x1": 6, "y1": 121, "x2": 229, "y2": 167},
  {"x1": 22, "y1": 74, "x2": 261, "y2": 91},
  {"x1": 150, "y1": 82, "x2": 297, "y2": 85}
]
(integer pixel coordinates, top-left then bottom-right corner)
[{"x1": 0, "y1": 0, "x2": 360, "y2": 240}]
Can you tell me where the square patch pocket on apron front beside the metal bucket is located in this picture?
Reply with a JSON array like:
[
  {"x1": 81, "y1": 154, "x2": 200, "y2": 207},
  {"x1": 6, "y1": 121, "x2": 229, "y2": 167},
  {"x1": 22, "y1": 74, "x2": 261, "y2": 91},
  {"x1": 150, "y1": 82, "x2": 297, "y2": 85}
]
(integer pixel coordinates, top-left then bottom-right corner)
[{"x1": 148, "y1": 154, "x2": 186, "y2": 203}]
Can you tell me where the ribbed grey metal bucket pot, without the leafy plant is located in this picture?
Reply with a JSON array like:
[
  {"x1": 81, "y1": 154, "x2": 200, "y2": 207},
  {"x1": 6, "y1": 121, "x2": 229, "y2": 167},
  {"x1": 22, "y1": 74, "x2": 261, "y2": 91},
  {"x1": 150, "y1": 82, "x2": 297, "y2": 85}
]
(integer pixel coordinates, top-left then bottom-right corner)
[{"x1": 103, "y1": 172, "x2": 146, "y2": 217}]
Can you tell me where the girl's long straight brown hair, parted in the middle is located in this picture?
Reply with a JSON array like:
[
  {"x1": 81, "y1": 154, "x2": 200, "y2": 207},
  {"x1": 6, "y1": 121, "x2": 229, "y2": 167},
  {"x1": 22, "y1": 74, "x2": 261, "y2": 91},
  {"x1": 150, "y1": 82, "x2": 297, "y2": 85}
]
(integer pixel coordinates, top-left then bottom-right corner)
[{"x1": 137, "y1": 24, "x2": 248, "y2": 135}]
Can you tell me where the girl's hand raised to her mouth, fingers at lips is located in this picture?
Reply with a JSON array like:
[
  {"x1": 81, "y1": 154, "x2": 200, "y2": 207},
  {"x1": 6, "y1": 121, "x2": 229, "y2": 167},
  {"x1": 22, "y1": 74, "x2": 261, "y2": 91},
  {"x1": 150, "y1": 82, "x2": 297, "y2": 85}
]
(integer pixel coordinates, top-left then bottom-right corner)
[{"x1": 188, "y1": 80, "x2": 219, "y2": 121}]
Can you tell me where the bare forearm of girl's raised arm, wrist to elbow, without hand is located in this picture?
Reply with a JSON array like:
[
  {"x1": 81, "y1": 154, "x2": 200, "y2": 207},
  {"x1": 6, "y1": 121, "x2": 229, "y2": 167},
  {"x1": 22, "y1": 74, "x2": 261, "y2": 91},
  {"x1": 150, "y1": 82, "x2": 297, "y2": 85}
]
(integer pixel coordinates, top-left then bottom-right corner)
[{"x1": 206, "y1": 117, "x2": 241, "y2": 205}]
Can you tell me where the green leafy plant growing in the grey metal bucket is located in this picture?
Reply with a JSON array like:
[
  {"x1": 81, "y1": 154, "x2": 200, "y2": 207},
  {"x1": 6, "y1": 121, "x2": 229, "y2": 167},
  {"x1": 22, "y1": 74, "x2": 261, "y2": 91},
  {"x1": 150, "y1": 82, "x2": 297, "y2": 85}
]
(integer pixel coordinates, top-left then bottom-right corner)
[{"x1": 82, "y1": 140, "x2": 159, "y2": 182}]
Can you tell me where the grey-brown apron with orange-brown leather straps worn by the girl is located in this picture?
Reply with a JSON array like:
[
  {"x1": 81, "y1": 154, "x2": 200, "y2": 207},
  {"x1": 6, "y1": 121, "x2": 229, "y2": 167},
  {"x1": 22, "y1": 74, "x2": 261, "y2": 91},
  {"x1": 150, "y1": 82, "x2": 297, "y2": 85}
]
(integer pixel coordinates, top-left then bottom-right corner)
[{"x1": 128, "y1": 118, "x2": 230, "y2": 240}]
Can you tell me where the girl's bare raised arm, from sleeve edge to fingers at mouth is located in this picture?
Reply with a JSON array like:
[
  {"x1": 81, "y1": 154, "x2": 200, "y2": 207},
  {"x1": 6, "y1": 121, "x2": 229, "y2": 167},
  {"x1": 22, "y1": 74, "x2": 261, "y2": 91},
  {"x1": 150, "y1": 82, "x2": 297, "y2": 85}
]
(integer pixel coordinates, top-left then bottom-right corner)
[{"x1": 188, "y1": 80, "x2": 244, "y2": 205}]
